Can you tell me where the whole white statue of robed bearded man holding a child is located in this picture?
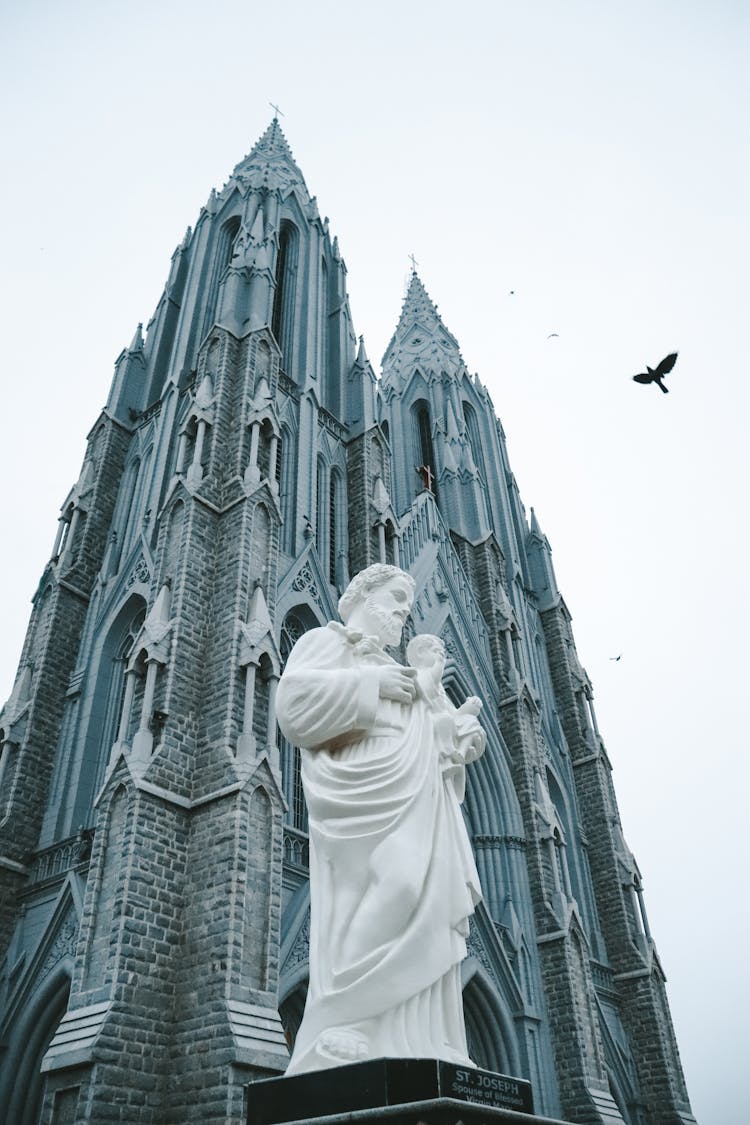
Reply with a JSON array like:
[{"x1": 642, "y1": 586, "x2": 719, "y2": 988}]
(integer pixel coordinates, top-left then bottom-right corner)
[{"x1": 277, "y1": 564, "x2": 485, "y2": 1073}]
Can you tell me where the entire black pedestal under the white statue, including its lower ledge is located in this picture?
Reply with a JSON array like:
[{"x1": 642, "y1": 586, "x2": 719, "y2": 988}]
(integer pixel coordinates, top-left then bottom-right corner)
[{"x1": 247, "y1": 1059, "x2": 568, "y2": 1125}]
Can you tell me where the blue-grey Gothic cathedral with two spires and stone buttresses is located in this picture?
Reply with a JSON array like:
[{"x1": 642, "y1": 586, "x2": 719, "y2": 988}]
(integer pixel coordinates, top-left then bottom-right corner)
[{"x1": 0, "y1": 119, "x2": 695, "y2": 1125}]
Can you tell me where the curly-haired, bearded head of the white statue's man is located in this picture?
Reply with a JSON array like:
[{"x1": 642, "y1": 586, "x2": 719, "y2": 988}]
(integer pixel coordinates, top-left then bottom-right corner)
[{"x1": 338, "y1": 563, "x2": 415, "y2": 645}]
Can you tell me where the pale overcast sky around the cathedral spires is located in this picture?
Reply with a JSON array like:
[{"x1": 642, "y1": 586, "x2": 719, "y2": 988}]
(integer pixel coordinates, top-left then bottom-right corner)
[{"x1": 0, "y1": 0, "x2": 750, "y2": 1125}]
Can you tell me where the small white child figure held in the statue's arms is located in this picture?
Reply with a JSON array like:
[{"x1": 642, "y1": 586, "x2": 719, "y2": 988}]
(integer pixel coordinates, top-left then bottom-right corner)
[{"x1": 406, "y1": 633, "x2": 487, "y2": 783}]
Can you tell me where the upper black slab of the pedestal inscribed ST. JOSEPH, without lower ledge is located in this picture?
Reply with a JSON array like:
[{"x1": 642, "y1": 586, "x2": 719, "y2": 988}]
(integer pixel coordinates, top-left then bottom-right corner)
[{"x1": 247, "y1": 1059, "x2": 534, "y2": 1125}]
